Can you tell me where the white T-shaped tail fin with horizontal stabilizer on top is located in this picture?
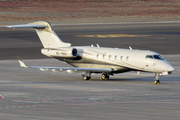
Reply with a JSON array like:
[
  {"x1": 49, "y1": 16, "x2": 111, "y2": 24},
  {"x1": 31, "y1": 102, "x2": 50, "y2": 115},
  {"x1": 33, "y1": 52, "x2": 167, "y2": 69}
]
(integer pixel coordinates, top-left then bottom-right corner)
[{"x1": 7, "y1": 21, "x2": 71, "y2": 48}]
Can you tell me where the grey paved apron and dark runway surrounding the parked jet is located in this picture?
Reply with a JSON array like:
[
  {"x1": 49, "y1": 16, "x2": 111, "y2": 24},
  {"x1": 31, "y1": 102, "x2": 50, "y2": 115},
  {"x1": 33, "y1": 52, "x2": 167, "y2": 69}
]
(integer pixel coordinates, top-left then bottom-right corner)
[{"x1": 0, "y1": 23, "x2": 180, "y2": 120}]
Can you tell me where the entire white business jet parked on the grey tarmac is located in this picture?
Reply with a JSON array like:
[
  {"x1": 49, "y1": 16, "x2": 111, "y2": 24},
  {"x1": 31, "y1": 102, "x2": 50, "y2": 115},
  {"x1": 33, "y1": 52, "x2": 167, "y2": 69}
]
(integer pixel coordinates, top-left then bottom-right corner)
[{"x1": 7, "y1": 21, "x2": 174, "y2": 84}]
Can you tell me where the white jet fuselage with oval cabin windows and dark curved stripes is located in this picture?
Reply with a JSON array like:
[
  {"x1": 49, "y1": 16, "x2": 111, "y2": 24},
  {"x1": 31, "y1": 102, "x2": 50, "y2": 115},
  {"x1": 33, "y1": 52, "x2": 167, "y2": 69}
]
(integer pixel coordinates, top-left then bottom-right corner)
[{"x1": 42, "y1": 46, "x2": 173, "y2": 73}]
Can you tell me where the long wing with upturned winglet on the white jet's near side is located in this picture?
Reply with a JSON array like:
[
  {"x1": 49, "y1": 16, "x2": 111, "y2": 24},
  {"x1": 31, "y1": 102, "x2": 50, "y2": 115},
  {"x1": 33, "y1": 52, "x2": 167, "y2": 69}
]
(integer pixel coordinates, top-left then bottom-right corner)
[{"x1": 18, "y1": 57, "x2": 112, "y2": 73}]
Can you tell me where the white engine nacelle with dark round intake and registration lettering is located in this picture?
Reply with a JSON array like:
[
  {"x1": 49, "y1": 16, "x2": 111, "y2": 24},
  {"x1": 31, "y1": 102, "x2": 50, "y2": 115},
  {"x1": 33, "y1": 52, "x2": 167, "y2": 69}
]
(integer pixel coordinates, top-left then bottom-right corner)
[{"x1": 41, "y1": 47, "x2": 78, "y2": 58}]
